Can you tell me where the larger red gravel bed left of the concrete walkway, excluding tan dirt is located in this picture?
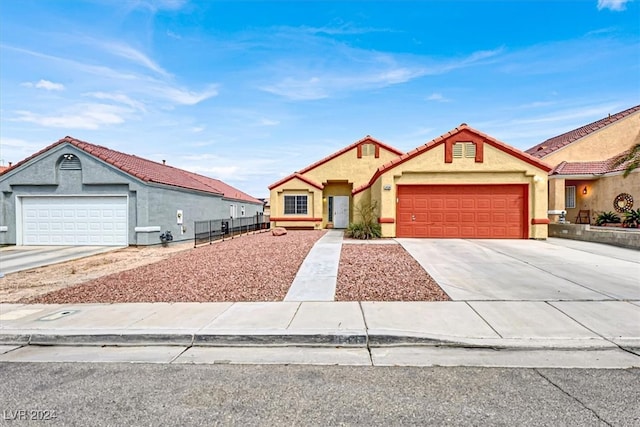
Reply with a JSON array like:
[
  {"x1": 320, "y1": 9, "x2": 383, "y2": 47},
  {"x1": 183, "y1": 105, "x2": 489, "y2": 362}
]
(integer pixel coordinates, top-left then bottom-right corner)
[{"x1": 22, "y1": 231, "x2": 324, "y2": 304}]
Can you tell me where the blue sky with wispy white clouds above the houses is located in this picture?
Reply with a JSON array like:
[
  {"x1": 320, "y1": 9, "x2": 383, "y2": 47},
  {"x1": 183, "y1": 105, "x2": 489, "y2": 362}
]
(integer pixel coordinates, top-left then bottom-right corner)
[{"x1": 0, "y1": 0, "x2": 640, "y2": 197}]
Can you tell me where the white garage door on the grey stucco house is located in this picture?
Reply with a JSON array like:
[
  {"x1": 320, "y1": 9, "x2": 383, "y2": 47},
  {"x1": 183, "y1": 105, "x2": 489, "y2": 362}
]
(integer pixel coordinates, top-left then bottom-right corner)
[{"x1": 22, "y1": 197, "x2": 128, "y2": 246}]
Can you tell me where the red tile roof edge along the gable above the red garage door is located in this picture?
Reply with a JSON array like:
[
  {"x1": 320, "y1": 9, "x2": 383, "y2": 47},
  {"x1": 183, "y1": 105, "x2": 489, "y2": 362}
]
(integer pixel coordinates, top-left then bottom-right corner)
[{"x1": 353, "y1": 123, "x2": 552, "y2": 194}]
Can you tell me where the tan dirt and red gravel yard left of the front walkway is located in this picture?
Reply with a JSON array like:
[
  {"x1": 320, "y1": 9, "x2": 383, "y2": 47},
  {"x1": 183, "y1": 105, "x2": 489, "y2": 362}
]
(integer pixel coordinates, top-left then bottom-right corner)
[{"x1": 0, "y1": 231, "x2": 324, "y2": 303}]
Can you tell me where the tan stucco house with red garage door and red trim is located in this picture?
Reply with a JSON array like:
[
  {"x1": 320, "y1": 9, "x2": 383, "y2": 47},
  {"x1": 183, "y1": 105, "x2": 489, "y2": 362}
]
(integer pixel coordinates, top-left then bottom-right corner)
[{"x1": 269, "y1": 123, "x2": 551, "y2": 239}]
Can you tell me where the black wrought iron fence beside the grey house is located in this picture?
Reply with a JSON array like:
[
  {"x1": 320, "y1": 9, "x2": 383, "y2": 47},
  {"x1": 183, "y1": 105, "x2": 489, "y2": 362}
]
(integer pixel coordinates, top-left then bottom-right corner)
[{"x1": 193, "y1": 215, "x2": 271, "y2": 247}]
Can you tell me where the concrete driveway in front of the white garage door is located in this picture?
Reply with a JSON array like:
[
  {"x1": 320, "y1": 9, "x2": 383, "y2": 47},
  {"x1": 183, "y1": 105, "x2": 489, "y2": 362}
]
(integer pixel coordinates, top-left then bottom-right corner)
[{"x1": 0, "y1": 246, "x2": 122, "y2": 274}]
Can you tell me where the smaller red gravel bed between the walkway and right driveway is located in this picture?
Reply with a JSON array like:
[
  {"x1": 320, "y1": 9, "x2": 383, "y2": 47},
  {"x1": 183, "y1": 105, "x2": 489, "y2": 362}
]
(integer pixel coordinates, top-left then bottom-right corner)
[{"x1": 335, "y1": 244, "x2": 450, "y2": 301}]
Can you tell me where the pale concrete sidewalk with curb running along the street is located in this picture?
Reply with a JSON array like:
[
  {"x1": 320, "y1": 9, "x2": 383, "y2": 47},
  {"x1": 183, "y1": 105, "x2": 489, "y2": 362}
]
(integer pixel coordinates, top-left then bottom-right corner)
[{"x1": 0, "y1": 301, "x2": 640, "y2": 352}]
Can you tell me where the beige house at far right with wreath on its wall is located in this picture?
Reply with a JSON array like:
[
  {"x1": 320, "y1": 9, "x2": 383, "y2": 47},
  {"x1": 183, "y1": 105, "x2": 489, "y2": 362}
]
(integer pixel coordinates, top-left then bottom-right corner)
[{"x1": 527, "y1": 105, "x2": 640, "y2": 224}]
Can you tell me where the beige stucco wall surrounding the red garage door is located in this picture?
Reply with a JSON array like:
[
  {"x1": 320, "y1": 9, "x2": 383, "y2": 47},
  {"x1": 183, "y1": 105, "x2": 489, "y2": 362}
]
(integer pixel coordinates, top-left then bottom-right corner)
[{"x1": 371, "y1": 144, "x2": 547, "y2": 239}]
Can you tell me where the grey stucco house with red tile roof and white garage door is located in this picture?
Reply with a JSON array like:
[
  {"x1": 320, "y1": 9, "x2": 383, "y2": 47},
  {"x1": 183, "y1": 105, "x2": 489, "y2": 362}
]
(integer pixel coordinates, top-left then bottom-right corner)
[{"x1": 0, "y1": 136, "x2": 263, "y2": 246}]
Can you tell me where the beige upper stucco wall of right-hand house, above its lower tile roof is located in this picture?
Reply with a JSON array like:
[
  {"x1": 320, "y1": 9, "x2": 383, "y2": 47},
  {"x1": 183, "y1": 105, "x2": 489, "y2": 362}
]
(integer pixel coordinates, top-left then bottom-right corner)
[{"x1": 542, "y1": 111, "x2": 640, "y2": 166}]
